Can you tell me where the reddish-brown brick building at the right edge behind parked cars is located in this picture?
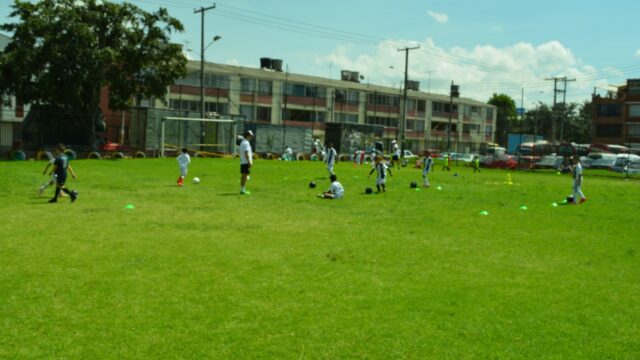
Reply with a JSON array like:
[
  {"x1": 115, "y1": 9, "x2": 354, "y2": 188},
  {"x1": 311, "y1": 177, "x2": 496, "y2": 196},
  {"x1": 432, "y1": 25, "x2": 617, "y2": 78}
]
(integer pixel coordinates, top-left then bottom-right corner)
[{"x1": 592, "y1": 79, "x2": 640, "y2": 149}]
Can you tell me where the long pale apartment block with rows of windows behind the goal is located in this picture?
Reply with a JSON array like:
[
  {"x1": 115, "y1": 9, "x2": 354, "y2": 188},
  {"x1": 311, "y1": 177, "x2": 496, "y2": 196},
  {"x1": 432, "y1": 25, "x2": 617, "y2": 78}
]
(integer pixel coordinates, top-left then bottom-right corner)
[{"x1": 152, "y1": 58, "x2": 497, "y2": 152}]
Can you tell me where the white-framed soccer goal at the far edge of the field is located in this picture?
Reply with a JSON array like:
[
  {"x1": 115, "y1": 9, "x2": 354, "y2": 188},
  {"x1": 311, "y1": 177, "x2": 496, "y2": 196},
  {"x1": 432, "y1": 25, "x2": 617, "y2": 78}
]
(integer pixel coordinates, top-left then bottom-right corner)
[{"x1": 158, "y1": 116, "x2": 236, "y2": 157}]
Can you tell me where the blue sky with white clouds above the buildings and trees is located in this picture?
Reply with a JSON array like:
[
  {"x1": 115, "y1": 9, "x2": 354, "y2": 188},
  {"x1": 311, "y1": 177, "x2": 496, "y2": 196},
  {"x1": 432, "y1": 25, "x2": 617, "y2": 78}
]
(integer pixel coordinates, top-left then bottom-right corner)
[{"x1": 0, "y1": 0, "x2": 640, "y2": 108}]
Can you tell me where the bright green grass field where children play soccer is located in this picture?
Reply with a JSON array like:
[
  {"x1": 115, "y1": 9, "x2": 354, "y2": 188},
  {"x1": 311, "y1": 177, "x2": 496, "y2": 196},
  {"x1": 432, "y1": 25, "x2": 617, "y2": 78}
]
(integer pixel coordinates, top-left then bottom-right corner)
[{"x1": 0, "y1": 158, "x2": 640, "y2": 359}]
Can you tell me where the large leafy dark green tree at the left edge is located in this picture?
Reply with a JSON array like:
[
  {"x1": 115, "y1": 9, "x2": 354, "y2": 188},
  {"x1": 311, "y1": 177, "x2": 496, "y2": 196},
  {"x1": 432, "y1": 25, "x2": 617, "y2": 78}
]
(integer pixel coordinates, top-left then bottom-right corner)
[{"x1": 0, "y1": 0, "x2": 187, "y2": 144}]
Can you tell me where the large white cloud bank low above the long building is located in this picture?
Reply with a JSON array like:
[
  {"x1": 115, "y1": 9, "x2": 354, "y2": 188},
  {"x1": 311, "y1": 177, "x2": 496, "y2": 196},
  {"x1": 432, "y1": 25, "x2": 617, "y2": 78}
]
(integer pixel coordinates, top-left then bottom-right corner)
[{"x1": 316, "y1": 39, "x2": 620, "y2": 107}]
